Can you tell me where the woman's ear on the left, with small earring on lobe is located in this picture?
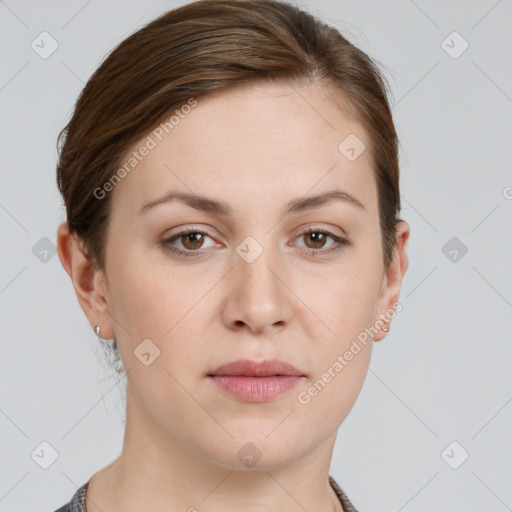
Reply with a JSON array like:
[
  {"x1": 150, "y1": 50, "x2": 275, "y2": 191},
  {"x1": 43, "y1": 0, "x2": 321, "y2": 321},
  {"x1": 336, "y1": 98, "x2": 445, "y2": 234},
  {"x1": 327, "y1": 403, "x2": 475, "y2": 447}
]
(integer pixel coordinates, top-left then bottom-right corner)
[{"x1": 57, "y1": 222, "x2": 115, "y2": 338}]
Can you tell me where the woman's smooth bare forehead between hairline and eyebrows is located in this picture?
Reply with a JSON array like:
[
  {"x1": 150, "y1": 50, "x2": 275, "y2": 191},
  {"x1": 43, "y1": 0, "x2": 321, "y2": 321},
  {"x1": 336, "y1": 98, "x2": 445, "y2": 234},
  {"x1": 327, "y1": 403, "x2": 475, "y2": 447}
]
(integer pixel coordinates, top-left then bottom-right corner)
[{"x1": 114, "y1": 83, "x2": 376, "y2": 215}]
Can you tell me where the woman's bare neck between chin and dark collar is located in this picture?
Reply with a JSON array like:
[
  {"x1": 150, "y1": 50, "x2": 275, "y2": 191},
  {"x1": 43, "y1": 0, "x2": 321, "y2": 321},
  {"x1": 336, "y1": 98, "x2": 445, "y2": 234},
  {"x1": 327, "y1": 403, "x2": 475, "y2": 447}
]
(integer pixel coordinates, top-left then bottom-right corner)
[{"x1": 86, "y1": 385, "x2": 343, "y2": 512}]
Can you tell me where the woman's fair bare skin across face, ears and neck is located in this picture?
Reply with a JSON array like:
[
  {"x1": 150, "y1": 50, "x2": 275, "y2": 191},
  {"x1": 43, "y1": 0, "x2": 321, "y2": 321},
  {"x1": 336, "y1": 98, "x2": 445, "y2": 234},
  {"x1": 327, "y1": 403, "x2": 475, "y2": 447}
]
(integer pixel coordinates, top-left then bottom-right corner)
[{"x1": 58, "y1": 83, "x2": 409, "y2": 512}]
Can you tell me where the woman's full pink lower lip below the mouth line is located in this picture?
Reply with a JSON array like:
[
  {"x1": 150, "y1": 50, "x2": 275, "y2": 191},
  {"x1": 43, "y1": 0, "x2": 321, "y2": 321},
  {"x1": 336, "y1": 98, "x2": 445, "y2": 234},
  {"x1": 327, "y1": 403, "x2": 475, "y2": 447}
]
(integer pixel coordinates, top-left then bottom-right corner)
[{"x1": 209, "y1": 375, "x2": 302, "y2": 402}]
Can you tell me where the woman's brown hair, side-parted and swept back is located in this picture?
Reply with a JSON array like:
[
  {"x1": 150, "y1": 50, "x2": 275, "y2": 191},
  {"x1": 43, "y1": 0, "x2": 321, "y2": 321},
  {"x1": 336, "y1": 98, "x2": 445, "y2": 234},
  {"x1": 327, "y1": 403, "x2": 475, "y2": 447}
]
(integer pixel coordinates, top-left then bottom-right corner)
[{"x1": 57, "y1": 0, "x2": 400, "y2": 269}]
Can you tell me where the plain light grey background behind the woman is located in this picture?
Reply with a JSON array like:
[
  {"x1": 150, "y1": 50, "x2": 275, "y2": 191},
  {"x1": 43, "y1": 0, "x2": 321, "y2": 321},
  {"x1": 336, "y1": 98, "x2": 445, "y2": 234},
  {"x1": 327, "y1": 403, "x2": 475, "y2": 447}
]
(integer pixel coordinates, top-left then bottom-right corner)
[{"x1": 0, "y1": 0, "x2": 512, "y2": 512}]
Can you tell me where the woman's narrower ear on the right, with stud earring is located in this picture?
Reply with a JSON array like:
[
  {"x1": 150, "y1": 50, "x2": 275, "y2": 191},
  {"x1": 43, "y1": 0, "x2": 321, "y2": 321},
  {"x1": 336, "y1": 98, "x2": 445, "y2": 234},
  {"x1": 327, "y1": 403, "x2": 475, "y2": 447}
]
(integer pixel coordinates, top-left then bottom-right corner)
[{"x1": 373, "y1": 220, "x2": 410, "y2": 341}]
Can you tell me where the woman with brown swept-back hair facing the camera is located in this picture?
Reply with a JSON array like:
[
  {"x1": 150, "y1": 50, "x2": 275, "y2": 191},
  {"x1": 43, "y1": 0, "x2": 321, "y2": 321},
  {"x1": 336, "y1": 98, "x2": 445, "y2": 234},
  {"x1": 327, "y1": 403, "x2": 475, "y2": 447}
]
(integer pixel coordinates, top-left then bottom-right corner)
[{"x1": 57, "y1": 0, "x2": 409, "y2": 512}]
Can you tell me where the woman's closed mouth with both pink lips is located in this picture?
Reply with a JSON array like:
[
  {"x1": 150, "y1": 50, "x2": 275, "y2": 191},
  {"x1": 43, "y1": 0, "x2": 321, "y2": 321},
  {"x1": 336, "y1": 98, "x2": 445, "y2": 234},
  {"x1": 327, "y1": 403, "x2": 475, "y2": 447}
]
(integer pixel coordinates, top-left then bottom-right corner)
[{"x1": 207, "y1": 359, "x2": 306, "y2": 402}]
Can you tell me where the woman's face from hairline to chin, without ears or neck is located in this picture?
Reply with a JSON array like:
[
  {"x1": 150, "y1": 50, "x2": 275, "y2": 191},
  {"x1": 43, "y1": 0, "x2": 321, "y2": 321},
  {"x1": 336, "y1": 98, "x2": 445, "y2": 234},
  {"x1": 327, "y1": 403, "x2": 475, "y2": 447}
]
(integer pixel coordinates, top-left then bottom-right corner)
[{"x1": 75, "y1": 84, "x2": 408, "y2": 468}]
